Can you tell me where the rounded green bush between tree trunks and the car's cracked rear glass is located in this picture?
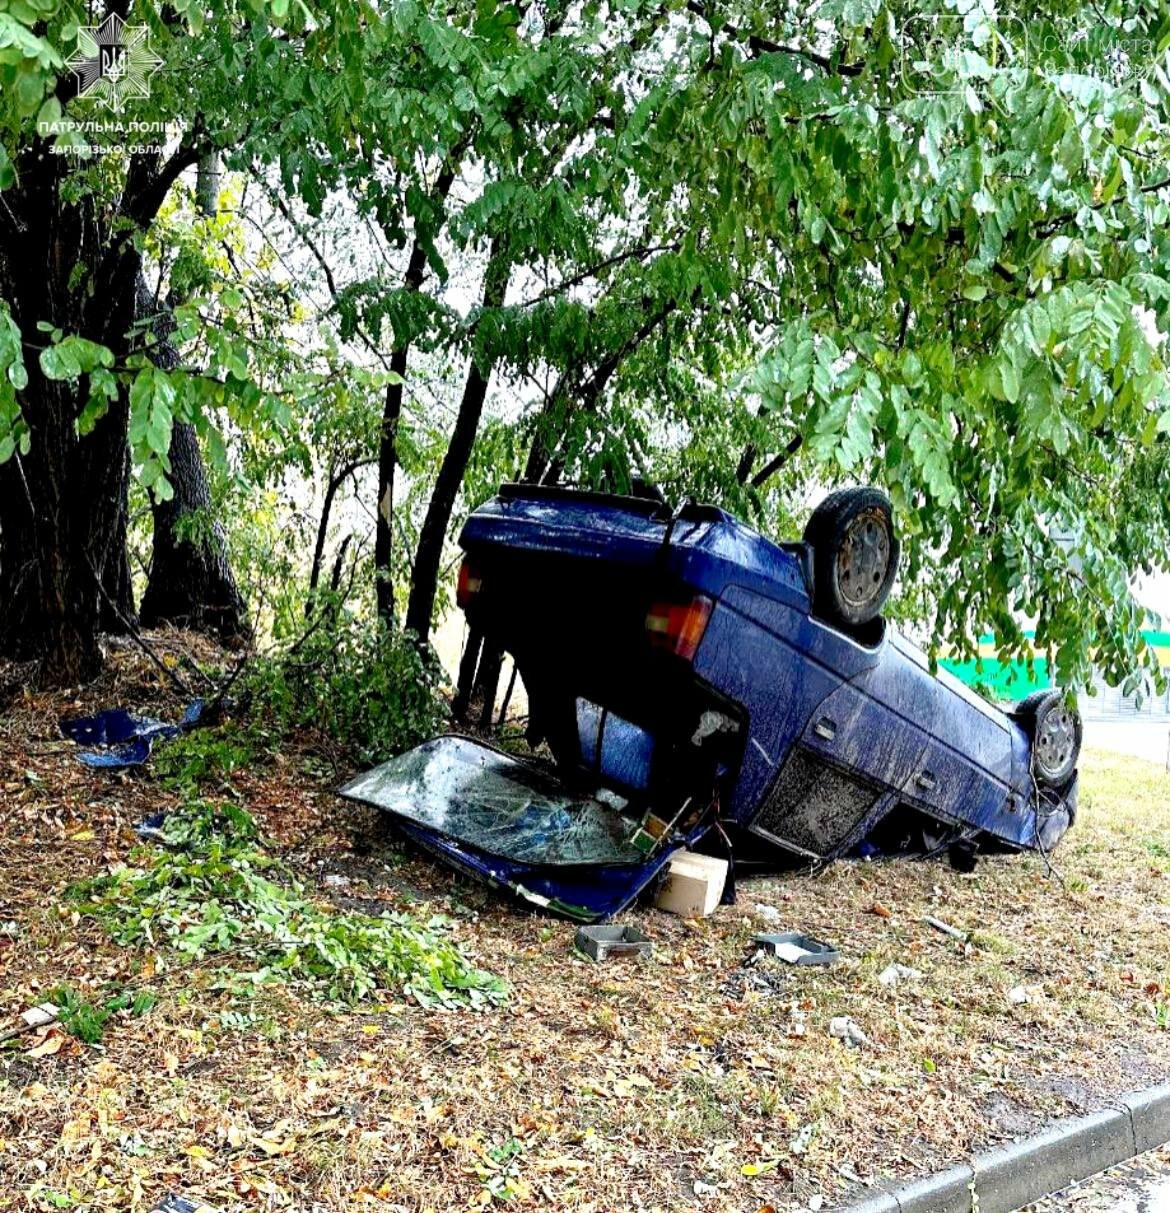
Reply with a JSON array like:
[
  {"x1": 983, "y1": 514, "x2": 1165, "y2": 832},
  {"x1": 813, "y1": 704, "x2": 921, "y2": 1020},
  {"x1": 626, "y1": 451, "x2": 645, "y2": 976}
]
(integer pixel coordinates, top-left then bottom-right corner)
[{"x1": 245, "y1": 616, "x2": 445, "y2": 763}]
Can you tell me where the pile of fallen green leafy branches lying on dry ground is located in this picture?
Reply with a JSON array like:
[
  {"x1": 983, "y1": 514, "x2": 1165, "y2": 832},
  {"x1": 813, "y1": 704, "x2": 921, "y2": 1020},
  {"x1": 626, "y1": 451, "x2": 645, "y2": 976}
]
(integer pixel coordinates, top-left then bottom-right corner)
[{"x1": 70, "y1": 801, "x2": 504, "y2": 1007}]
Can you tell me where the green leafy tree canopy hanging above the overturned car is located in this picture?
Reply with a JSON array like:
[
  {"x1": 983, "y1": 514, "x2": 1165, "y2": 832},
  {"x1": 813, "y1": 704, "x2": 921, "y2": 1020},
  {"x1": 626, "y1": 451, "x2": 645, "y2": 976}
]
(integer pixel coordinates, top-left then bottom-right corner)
[{"x1": 0, "y1": 0, "x2": 1170, "y2": 683}]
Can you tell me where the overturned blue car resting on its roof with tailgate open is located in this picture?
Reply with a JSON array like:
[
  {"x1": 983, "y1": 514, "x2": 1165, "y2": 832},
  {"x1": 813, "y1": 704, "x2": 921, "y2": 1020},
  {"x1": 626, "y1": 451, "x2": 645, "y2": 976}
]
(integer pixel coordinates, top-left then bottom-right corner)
[{"x1": 342, "y1": 485, "x2": 1081, "y2": 921}]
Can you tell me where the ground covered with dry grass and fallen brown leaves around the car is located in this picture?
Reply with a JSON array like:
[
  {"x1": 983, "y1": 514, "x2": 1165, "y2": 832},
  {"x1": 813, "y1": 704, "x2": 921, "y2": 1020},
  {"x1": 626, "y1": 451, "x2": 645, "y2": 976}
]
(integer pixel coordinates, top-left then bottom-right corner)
[{"x1": 0, "y1": 645, "x2": 1170, "y2": 1213}]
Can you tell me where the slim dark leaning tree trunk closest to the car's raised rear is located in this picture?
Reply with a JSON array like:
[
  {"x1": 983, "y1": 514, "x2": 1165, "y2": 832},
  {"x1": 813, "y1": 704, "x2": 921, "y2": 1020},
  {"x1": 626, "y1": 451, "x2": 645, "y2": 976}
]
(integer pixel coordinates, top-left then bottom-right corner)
[{"x1": 406, "y1": 237, "x2": 512, "y2": 644}]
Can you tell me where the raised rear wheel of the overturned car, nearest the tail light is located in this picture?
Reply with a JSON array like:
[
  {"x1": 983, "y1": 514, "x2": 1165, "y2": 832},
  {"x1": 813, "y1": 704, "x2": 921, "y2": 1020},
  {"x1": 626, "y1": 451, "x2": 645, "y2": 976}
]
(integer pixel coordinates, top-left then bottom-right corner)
[{"x1": 804, "y1": 489, "x2": 901, "y2": 627}]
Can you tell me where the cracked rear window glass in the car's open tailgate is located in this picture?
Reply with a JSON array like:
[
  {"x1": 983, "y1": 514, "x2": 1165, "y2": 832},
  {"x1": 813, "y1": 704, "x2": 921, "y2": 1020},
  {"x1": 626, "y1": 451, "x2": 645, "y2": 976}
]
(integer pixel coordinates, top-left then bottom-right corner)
[{"x1": 341, "y1": 736, "x2": 646, "y2": 865}]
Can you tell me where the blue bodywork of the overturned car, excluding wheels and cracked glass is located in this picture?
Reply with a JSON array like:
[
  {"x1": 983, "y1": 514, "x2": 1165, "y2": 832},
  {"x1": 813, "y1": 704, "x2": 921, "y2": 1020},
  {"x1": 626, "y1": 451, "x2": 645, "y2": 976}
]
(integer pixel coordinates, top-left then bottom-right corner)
[{"x1": 344, "y1": 486, "x2": 1075, "y2": 917}]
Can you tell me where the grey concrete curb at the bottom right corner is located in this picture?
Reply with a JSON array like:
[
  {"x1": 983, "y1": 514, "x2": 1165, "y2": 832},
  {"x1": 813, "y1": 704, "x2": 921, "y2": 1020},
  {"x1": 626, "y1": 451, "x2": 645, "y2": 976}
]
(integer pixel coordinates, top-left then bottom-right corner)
[{"x1": 845, "y1": 1082, "x2": 1170, "y2": 1213}]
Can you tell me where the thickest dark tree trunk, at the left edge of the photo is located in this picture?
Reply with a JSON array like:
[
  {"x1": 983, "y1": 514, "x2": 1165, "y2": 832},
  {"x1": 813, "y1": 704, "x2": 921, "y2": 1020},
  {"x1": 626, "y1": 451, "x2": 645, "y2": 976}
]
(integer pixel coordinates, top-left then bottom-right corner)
[{"x1": 0, "y1": 138, "x2": 170, "y2": 685}]
